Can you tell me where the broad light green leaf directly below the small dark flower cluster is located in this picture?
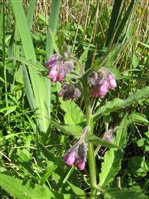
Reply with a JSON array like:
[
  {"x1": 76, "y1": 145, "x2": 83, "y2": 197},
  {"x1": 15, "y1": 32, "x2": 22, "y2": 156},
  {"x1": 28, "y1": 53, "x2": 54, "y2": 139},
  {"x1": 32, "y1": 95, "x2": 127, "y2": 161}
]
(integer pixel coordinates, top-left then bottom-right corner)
[{"x1": 61, "y1": 100, "x2": 85, "y2": 125}]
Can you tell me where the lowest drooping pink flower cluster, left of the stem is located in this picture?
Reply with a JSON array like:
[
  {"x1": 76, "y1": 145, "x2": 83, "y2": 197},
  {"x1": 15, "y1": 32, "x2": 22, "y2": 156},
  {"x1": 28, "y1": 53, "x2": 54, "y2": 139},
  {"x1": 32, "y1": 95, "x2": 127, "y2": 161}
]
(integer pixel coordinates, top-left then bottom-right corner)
[{"x1": 64, "y1": 142, "x2": 87, "y2": 170}]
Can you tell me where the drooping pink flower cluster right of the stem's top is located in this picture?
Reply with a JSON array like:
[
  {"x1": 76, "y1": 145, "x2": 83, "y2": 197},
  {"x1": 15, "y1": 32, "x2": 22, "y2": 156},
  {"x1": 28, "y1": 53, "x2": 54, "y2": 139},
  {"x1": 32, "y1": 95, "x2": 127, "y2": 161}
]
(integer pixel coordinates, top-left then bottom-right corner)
[{"x1": 88, "y1": 68, "x2": 116, "y2": 98}]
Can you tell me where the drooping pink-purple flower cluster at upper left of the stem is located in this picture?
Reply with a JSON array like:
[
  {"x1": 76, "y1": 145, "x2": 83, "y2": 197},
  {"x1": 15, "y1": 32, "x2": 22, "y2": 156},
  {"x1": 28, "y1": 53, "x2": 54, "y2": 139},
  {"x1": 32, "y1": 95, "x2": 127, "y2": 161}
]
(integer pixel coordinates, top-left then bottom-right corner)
[{"x1": 45, "y1": 54, "x2": 74, "y2": 82}]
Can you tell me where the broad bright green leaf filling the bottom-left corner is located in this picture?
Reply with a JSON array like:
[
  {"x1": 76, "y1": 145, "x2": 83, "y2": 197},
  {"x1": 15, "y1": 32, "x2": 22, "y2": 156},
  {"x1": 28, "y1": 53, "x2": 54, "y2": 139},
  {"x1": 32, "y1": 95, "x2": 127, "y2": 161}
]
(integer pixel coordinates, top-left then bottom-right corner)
[{"x1": 0, "y1": 173, "x2": 56, "y2": 199}]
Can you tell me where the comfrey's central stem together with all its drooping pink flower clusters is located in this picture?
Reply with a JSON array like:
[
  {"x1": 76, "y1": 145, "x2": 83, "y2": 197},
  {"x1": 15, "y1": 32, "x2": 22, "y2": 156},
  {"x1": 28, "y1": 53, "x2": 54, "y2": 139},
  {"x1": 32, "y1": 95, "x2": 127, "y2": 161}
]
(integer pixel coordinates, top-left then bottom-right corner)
[{"x1": 45, "y1": 48, "x2": 117, "y2": 196}]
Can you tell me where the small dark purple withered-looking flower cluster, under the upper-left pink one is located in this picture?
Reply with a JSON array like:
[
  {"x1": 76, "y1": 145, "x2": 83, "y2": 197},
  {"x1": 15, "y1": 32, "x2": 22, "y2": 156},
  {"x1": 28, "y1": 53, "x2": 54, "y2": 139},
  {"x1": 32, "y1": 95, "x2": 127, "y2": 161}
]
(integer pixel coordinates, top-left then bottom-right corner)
[{"x1": 59, "y1": 84, "x2": 81, "y2": 100}]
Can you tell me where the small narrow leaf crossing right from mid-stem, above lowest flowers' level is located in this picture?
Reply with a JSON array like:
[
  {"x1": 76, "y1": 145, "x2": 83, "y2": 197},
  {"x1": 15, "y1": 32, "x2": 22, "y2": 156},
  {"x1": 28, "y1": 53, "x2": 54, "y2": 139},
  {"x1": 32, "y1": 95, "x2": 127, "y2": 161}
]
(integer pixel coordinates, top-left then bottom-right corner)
[{"x1": 86, "y1": 135, "x2": 118, "y2": 148}]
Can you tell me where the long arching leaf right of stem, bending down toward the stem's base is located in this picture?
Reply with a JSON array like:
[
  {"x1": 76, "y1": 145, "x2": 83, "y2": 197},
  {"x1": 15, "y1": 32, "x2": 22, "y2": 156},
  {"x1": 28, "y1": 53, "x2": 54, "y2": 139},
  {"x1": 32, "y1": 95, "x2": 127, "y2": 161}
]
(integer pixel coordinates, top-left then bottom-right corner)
[{"x1": 99, "y1": 113, "x2": 148, "y2": 186}]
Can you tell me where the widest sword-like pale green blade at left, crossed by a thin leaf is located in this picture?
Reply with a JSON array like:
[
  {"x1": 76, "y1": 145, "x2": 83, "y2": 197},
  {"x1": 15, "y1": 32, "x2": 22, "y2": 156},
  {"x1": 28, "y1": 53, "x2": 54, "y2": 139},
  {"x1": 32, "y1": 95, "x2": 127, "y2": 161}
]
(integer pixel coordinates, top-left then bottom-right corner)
[{"x1": 11, "y1": 0, "x2": 51, "y2": 132}]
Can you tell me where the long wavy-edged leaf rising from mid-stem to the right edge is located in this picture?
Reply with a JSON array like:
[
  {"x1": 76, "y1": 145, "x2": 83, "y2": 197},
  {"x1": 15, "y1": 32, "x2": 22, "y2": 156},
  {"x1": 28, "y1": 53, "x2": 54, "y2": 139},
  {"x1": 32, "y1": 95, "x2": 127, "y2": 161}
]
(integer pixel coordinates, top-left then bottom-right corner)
[{"x1": 93, "y1": 86, "x2": 149, "y2": 120}]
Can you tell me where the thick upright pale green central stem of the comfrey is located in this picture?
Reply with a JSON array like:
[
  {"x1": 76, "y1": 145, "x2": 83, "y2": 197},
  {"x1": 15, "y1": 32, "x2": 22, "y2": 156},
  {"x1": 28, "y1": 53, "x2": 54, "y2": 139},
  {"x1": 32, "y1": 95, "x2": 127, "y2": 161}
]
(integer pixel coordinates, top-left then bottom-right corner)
[{"x1": 82, "y1": 76, "x2": 97, "y2": 199}]
